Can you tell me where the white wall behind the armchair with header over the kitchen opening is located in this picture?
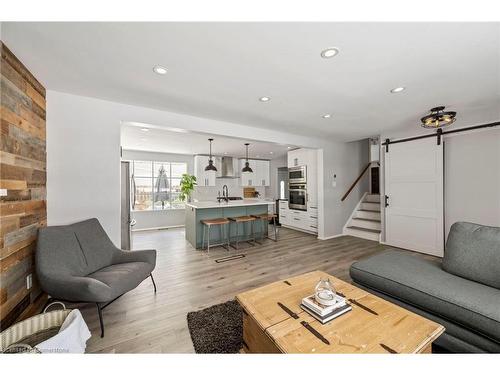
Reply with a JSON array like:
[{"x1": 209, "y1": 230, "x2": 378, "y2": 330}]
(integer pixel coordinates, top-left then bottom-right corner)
[{"x1": 47, "y1": 90, "x2": 330, "y2": 244}]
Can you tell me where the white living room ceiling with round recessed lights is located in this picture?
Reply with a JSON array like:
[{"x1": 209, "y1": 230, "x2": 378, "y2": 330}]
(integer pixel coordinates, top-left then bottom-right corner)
[{"x1": 2, "y1": 22, "x2": 500, "y2": 140}]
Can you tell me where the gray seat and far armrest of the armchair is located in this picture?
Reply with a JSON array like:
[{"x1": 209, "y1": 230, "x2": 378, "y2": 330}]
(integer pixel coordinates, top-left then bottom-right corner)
[{"x1": 87, "y1": 262, "x2": 154, "y2": 300}]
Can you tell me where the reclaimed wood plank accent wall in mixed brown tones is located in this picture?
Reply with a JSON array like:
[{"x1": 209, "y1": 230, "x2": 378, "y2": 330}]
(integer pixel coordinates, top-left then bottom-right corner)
[{"x1": 0, "y1": 42, "x2": 47, "y2": 330}]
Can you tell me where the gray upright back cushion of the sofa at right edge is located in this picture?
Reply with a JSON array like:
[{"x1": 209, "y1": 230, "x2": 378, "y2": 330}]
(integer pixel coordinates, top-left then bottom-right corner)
[{"x1": 443, "y1": 222, "x2": 500, "y2": 289}]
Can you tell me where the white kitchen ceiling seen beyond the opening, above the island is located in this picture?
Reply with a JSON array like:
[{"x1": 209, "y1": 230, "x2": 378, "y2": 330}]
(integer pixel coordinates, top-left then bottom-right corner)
[{"x1": 121, "y1": 123, "x2": 295, "y2": 159}]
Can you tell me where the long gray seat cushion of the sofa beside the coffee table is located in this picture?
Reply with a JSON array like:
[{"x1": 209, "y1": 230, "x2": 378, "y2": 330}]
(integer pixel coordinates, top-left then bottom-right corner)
[{"x1": 350, "y1": 250, "x2": 500, "y2": 342}]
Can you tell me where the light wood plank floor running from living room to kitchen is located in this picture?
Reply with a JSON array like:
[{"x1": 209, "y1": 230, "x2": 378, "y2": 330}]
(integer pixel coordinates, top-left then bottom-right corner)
[{"x1": 80, "y1": 228, "x2": 402, "y2": 353}]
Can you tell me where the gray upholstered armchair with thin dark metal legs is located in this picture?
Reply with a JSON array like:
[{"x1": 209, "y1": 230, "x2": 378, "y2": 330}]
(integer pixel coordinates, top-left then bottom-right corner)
[{"x1": 36, "y1": 219, "x2": 156, "y2": 337}]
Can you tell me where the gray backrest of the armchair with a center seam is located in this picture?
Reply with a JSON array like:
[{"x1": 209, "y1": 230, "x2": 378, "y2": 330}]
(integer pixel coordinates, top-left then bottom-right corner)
[{"x1": 36, "y1": 219, "x2": 116, "y2": 278}]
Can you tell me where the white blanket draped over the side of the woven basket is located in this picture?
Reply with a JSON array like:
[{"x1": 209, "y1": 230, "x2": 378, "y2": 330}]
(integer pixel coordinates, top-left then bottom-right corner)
[{"x1": 36, "y1": 309, "x2": 91, "y2": 354}]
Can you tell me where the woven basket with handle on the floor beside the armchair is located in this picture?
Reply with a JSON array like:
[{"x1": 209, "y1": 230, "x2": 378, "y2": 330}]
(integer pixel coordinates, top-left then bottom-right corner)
[{"x1": 0, "y1": 302, "x2": 71, "y2": 353}]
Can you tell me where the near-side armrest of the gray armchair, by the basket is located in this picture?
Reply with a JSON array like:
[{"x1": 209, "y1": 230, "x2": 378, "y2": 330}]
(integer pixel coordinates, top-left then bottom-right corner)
[{"x1": 38, "y1": 275, "x2": 111, "y2": 302}]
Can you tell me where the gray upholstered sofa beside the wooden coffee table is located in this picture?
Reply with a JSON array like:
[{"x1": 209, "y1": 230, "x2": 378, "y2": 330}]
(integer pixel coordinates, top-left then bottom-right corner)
[{"x1": 350, "y1": 222, "x2": 500, "y2": 353}]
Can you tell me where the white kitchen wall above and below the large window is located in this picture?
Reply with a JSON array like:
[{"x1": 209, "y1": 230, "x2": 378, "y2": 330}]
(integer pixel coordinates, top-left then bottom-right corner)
[{"x1": 122, "y1": 150, "x2": 194, "y2": 230}]
